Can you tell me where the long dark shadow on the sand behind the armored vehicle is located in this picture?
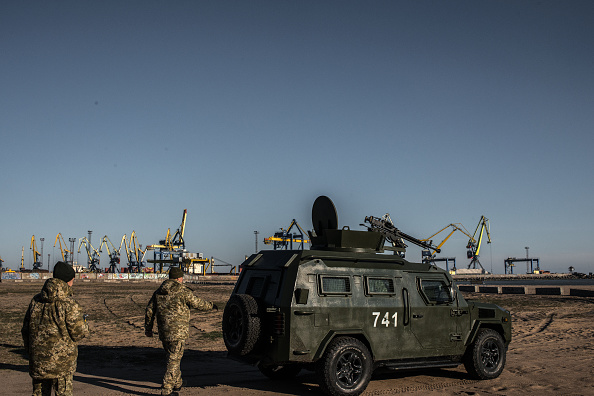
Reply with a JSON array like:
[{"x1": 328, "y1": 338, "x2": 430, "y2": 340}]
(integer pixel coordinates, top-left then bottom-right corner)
[{"x1": 74, "y1": 345, "x2": 321, "y2": 395}]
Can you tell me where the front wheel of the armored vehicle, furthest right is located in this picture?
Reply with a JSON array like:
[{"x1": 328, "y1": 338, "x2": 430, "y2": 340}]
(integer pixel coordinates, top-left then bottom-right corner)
[{"x1": 464, "y1": 329, "x2": 506, "y2": 379}]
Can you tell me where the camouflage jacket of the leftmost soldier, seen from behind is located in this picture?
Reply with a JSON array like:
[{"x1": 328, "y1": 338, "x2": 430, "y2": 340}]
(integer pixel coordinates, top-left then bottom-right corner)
[{"x1": 21, "y1": 278, "x2": 89, "y2": 379}]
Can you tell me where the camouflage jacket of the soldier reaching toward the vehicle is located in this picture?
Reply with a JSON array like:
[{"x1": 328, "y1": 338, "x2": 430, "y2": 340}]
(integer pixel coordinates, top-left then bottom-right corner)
[{"x1": 144, "y1": 279, "x2": 212, "y2": 341}]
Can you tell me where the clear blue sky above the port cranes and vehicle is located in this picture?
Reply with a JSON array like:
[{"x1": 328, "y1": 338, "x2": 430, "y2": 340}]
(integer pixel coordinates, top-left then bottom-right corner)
[{"x1": 0, "y1": 1, "x2": 594, "y2": 273}]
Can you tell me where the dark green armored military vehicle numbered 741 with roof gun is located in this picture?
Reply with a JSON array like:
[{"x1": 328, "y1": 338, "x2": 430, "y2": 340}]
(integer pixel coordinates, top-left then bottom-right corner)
[{"x1": 222, "y1": 196, "x2": 511, "y2": 395}]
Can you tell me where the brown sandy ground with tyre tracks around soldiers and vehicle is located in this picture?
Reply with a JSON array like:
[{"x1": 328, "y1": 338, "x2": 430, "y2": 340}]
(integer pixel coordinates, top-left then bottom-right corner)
[{"x1": 0, "y1": 281, "x2": 594, "y2": 395}]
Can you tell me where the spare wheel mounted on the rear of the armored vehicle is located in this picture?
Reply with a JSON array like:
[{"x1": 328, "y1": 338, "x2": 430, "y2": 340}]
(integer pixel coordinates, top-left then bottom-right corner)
[{"x1": 223, "y1": 294, "x2": 260, "y2": 356}]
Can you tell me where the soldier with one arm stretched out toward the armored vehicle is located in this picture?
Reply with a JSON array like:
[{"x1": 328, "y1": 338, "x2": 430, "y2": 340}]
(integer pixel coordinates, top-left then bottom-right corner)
[{"x1": 144, "y1": 267, "x2": 218, "y2": 395}]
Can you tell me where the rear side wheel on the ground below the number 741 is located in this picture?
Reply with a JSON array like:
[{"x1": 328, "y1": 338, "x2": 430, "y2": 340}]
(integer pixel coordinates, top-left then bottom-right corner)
[{"x1": 318, "y1": 337, "x2": 373, "y2": 396}]
